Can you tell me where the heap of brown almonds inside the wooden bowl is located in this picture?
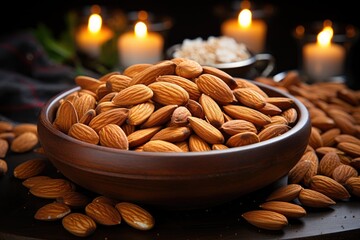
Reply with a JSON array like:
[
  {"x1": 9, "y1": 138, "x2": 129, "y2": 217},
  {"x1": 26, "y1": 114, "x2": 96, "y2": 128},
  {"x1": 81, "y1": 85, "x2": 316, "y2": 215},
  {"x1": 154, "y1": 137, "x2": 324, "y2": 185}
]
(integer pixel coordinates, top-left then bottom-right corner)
[{"x1": 53, "y1": 58, "x2": 297, "y2": 152}]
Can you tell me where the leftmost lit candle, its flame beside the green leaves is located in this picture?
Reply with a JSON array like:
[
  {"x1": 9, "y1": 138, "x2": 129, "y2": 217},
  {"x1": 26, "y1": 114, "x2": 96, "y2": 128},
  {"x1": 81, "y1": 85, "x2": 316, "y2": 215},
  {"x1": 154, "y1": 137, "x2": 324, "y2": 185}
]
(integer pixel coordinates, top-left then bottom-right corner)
[{"x1": 76, "y1": 6, "x2": 113, "y2": 58}]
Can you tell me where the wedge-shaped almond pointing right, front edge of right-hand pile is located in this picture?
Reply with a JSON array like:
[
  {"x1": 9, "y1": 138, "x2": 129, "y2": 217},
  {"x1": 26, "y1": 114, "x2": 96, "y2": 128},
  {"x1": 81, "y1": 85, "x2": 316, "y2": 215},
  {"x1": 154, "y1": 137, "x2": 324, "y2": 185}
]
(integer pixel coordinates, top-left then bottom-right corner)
[{"x1": 298, "y1": 188, "x2": 336, "y2": 208}]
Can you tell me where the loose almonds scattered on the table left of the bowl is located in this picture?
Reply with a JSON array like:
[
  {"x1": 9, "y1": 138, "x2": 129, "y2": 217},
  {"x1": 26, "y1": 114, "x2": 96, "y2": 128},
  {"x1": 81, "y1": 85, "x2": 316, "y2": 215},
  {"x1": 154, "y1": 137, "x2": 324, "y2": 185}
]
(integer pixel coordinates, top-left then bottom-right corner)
[{"x1": 0, "y1": 121, "x2": 155, "y2": 237}]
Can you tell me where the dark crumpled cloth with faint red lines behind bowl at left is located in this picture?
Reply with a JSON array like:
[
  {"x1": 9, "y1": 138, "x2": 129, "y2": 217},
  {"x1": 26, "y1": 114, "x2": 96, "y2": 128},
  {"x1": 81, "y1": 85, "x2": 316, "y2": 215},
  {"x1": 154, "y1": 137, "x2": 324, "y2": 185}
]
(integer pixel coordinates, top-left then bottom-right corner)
[{"x1": 0, "y1": 31, "x2": 97, "y2": 123}]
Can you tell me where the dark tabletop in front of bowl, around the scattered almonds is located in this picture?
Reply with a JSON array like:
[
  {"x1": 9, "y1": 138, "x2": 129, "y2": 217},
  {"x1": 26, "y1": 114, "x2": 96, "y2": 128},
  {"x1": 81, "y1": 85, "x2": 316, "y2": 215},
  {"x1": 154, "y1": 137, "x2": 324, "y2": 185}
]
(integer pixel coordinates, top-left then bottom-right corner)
[{"x1": 0, "y1": 152, "x2": 360, "y2": 240}]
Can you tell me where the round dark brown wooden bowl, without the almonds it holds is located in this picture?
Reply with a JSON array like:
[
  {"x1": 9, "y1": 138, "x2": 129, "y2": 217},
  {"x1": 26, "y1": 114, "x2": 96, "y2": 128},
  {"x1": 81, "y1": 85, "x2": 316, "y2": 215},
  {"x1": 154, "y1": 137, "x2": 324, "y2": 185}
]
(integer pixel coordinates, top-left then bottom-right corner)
[{"x1": 38, "y1": 82, "x2": 311, "y2": 209}]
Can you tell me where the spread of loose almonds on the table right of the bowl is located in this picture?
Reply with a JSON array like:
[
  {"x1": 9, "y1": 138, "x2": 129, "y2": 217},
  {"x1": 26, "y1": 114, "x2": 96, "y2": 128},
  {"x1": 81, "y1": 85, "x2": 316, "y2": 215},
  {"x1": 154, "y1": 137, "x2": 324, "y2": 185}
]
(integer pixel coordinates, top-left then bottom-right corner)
[{"x1": 242, "y1": 71, "x2": 360, "y2": 230}]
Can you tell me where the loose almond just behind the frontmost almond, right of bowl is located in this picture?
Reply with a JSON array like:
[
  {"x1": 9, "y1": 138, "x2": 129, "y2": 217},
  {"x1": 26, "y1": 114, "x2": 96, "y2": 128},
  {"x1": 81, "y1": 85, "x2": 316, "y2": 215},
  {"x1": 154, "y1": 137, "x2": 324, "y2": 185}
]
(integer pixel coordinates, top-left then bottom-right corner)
[{"x1": 259, "y1": 201, "x2": 306, "y2": 218}]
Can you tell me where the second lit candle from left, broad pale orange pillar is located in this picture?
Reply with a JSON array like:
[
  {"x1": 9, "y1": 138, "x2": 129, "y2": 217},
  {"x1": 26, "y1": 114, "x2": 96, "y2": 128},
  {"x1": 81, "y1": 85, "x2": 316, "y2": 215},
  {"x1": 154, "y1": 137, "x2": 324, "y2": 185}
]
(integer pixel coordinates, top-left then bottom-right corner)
[{"x1": 118, "y1": 21, "x2": 164, "y2": 67}]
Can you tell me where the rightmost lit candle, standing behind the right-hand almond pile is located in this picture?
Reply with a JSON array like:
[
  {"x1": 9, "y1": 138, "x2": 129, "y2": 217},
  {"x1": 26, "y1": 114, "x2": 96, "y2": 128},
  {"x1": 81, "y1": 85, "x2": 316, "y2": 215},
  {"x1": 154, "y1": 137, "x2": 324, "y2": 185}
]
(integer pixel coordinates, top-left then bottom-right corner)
[{"x1": 303, "y1": 20, "x2": 345, "y2": 81}]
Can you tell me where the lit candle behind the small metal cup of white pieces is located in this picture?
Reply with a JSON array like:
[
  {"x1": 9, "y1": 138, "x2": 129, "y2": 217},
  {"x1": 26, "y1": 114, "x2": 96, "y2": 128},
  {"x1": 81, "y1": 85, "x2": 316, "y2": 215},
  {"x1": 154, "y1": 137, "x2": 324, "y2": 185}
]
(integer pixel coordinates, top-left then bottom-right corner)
[{"x1": 221, "y1": 1, "x2": 267, "y2": 54}]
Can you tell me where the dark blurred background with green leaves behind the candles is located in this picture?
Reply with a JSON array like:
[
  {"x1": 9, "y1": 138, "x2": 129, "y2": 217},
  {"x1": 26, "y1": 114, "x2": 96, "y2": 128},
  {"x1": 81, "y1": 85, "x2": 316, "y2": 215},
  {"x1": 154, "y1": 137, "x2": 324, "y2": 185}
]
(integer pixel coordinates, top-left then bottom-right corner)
[{"x1": 0, "y1": 0, "x2": 360, "y2": 123}]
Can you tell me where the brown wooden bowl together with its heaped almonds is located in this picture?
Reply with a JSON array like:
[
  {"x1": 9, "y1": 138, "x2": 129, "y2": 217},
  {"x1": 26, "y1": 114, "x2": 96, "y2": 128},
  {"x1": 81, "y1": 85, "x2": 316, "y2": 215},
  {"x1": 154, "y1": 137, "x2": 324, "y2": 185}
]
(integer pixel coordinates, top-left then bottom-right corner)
[{"x1": 38, "y1": 58, "x2": 311, "y2": 209}]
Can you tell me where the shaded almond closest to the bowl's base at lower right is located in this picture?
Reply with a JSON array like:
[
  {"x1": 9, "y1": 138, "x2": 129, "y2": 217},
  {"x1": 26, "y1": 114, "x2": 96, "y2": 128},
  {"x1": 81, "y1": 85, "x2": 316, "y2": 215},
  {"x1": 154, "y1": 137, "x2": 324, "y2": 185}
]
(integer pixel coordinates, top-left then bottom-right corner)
[{"x1": 266, "y1": 183, "x2": 303, "y2": 202}]
